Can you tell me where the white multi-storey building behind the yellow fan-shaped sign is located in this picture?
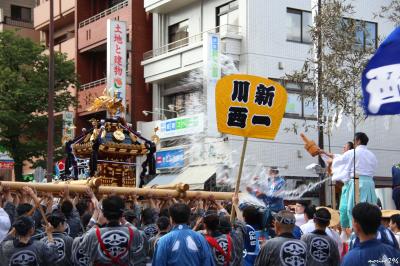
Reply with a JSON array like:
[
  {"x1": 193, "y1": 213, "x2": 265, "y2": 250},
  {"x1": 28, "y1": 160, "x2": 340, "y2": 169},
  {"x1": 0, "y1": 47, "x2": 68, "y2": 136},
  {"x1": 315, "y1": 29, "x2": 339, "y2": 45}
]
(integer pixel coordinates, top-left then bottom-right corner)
[{"x1": 139, "y1": 0, "x2": 400, "y2": 203}]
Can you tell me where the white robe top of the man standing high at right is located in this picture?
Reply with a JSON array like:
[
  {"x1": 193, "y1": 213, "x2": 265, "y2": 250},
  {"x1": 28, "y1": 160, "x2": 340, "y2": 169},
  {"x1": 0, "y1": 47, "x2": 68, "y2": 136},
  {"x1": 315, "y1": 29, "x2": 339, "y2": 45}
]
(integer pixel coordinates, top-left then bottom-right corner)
[{"x1": 332, "y1": 145, "x2": 378, "y2": 182}]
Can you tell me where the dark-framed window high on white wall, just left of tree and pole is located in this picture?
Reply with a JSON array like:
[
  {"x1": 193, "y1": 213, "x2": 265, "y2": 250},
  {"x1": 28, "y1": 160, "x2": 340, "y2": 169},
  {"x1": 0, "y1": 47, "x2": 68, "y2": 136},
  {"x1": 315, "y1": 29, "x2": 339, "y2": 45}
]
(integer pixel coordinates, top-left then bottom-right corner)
[{"x1": 287, "y1": 8, "x2": 312, "y2": 43}]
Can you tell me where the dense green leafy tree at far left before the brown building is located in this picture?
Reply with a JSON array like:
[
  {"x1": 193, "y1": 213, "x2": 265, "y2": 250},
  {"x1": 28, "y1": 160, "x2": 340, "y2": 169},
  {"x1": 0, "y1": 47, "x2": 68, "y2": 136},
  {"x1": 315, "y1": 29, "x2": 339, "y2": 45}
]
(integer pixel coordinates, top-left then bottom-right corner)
[{"x1": 0, "y1": 31, "x2": 77, "y2": 179}]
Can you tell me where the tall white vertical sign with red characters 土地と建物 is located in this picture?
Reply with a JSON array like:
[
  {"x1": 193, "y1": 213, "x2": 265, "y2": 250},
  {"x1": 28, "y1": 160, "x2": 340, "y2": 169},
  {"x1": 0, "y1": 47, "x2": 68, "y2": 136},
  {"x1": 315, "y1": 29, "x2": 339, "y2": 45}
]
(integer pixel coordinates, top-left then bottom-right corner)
[{"x1": 107, "y1": 19, "x2": 126, "y2": 115}]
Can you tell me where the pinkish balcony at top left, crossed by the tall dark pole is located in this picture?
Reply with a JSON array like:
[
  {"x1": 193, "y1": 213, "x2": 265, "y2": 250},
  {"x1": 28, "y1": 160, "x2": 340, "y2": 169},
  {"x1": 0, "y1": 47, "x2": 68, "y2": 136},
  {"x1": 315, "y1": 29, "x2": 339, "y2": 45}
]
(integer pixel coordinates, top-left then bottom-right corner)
[{"x1": 33, "y1": 0, "x2": 75, "y2": 30}]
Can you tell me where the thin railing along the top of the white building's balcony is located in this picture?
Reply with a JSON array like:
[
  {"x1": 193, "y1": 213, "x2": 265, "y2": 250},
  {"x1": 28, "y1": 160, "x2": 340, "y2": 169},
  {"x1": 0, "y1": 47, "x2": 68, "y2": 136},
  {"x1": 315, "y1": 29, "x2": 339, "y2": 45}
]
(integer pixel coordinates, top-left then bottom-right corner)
[{"x1": 143, "y1": 24, "x2": 241, "y2": 60}]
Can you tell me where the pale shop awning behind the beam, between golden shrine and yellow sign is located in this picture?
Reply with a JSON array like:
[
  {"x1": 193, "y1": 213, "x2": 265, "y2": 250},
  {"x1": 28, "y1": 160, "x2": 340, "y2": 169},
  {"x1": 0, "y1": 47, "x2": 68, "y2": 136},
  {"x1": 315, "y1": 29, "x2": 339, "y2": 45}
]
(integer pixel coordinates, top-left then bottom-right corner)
[{"x1": 146, "y1": 165, "x2": 216, "y2": 190}]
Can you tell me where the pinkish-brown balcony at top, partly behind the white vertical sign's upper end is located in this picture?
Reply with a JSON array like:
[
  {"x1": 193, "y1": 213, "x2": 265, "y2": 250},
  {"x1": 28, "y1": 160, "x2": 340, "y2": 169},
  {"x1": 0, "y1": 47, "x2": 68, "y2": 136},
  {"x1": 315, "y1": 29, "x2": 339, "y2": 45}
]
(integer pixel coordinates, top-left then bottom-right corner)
[{"x1": 78, "y1": 0, "x2": 132, "y2": 53}]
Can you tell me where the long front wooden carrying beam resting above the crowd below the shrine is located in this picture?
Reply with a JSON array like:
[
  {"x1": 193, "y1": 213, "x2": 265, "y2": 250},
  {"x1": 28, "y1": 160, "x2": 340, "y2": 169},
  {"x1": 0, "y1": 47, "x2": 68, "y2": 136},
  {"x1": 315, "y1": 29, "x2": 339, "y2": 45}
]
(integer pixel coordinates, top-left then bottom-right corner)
[{"x1": 0, "y1": 181, "x2": 233, "y2": 200}]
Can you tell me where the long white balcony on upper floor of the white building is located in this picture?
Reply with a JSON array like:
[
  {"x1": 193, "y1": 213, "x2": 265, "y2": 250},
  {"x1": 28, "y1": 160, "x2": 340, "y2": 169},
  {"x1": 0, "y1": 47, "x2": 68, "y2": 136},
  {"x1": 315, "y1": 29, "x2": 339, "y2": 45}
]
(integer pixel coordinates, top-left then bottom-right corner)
[{"x1": 142, "y1": 25, "x2": 242, "y2": 83}]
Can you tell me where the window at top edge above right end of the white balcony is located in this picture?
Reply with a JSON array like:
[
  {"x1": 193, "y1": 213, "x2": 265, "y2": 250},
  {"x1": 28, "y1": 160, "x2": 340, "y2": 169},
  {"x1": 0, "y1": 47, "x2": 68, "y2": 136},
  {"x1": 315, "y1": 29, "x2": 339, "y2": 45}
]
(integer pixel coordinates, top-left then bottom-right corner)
[{"x1": 217, "y1": 0, "x2": 239, "y2": 31}]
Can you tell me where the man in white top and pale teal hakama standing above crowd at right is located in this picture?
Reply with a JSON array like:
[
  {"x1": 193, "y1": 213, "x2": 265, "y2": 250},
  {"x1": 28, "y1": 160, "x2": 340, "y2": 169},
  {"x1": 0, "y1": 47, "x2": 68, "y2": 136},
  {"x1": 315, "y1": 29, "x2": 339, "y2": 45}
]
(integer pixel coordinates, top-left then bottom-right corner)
[{"x1": 326, "y1": 132, "x2": 378, "y2": 228}]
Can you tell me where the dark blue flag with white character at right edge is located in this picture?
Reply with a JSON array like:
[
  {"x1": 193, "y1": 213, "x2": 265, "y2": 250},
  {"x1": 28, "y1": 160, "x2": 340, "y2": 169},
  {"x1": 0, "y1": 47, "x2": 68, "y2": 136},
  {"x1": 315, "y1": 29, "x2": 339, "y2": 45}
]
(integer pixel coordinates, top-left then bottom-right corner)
[{"x1": 362, "y1": 27, "x2": 400, "y2": 115}]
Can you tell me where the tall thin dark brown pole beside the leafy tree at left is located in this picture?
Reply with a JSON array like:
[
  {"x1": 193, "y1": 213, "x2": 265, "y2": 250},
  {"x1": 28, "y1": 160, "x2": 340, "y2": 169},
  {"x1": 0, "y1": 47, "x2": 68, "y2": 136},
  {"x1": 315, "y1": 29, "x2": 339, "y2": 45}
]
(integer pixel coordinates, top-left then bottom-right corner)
[{"x1": 47, "y1": 0, "x2": 54, "y2": 182}]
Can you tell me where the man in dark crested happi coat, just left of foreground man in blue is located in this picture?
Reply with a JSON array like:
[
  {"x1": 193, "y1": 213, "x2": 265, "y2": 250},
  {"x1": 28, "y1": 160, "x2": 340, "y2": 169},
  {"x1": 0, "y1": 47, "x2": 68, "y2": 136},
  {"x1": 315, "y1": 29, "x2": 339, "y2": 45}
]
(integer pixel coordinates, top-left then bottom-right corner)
[{"x1": 301, "y1": 208, "x2": 340, "y2": 266}]
